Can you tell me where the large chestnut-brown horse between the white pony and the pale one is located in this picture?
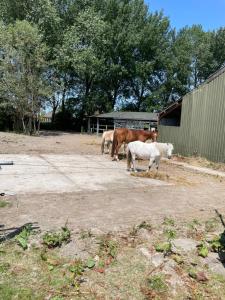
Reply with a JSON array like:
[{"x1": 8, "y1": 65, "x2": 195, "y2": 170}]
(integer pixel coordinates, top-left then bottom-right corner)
[{"x1": 111, "y1": 128, "x2": 158, "y2": 160}]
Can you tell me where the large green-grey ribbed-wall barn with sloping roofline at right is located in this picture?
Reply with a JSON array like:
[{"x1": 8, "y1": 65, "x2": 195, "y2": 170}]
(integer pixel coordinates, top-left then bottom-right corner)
[{"x1": 158, "y1": 67, "x2": 225, "y2": 162}]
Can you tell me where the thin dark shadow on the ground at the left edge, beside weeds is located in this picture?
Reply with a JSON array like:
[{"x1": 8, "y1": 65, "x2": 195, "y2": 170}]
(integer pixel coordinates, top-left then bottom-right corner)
[{"x1": 0, "y1": 222, "x2": 40, "y2": 243}]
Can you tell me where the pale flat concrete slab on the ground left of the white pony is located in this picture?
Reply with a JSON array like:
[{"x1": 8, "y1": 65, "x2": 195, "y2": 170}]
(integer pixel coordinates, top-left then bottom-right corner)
[{"x1": 0, "y1": 154, "x2": 168, "y2": 194}]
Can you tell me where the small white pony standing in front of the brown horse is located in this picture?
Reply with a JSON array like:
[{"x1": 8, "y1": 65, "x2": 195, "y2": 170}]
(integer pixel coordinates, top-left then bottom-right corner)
[{"x1": 127, "y1": 141, "x2": 173, "y2": 172}]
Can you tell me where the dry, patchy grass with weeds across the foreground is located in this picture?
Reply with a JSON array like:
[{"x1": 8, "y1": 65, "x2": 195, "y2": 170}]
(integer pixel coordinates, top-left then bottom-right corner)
[{"x1": 0, "y1": 218, "x2": 225, "y2": 300}]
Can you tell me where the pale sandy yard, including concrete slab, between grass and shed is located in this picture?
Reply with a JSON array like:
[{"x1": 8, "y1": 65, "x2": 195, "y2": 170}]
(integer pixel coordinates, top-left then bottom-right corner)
[{"x1": 0, "y1": 132, "x2": 225, "y2": 231}]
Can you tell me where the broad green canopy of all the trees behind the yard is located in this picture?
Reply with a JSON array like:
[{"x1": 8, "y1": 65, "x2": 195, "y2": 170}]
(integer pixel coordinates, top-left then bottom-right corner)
[{"x1": 0, "y1": 0, "x2": 225, "y2": 133}]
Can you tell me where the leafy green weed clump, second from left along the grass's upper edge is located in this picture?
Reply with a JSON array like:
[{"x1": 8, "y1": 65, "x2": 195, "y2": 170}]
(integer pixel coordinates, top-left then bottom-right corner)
[{"x1": 42, "y1": 226, "x2": 71, "y2": 248}]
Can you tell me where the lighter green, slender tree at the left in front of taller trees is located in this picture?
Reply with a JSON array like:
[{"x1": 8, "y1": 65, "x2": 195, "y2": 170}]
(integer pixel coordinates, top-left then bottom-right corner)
[{"x1": 0, "y1": 21, "x2": 50, "y2": 134}]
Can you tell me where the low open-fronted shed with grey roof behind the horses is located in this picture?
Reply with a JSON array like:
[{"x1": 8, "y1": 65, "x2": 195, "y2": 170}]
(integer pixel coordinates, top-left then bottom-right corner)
[{"x1": 88, "y1": 111, "x2": 158, "y2": 134}]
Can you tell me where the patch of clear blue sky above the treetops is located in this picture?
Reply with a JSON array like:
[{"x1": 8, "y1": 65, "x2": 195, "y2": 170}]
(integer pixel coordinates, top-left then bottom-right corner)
[{"x1": 145, "y1": 0, "x2": 225, "y2": 31}]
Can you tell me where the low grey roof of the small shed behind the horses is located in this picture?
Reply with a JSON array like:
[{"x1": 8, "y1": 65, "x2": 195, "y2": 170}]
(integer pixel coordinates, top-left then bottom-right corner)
[{"x1": 92, "y1": 111, "x2": 158, "y2": 122}]
